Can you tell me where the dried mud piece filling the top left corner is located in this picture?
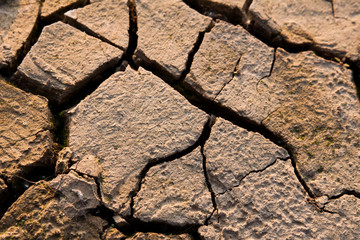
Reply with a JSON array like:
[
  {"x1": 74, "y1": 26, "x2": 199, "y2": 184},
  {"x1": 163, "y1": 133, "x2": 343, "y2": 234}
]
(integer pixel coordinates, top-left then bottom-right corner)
[{"x1": 0, "y1": 0, "x2": 40, "y2": 69}]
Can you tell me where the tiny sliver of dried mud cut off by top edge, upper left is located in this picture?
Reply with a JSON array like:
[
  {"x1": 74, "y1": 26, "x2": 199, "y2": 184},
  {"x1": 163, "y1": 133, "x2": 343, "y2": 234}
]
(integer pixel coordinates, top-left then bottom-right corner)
[{"x1": 41, "y1": 0, "x2": 88, "y2": 18}]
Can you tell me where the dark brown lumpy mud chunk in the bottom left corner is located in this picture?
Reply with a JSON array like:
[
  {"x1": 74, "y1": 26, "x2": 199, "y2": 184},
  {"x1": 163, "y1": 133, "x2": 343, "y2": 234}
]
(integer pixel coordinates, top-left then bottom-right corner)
[{"x1": 0, "y1": 172, "x2": 106, "y2": 239}]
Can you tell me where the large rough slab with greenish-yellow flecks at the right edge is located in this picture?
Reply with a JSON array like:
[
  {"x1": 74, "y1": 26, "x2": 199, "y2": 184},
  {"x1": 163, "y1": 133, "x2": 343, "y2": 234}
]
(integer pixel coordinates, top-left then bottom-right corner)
[{"x1": 259, "y1": 50, "x2": 360, "y2": 196}]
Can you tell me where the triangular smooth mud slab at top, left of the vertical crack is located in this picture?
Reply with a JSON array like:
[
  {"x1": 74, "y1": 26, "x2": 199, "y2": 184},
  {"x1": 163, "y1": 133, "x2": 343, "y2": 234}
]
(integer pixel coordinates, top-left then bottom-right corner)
[{"x1": 65, "y1": 0, "x2": 129, "y2": 50}]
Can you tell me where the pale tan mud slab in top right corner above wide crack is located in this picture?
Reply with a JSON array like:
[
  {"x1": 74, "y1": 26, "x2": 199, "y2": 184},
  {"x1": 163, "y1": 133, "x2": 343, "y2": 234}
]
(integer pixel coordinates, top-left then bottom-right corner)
[{"x1": 250, "y1": 0, "x2": 360, "y2": 61}]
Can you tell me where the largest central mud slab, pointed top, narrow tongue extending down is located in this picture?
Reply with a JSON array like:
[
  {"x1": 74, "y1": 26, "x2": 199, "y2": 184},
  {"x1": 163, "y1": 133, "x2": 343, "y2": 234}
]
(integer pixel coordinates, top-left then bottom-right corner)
[{"x1": 69, "y1": 68, "x2": 208, "y2": 216}]
